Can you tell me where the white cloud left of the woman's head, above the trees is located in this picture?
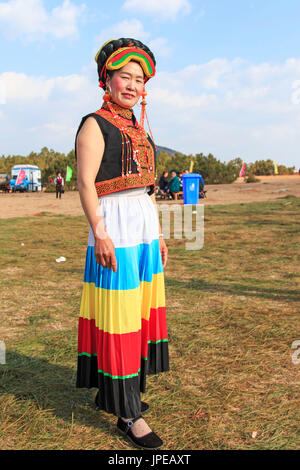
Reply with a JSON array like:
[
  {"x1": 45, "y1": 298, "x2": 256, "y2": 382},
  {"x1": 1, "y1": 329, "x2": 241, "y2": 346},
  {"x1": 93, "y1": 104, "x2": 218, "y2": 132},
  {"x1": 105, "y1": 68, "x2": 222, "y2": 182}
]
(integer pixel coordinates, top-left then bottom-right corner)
[{"x1": 0, "y1": 72, "x2": 98, "y2": 155}]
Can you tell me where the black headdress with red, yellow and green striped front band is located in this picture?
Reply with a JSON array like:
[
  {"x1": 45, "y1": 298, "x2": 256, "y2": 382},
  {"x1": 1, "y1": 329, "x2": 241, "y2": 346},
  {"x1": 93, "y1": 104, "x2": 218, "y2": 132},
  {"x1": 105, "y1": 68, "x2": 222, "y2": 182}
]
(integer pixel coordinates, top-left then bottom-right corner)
[{"x1": 95, "y1": 38, "x2": 156, "y2": 89}]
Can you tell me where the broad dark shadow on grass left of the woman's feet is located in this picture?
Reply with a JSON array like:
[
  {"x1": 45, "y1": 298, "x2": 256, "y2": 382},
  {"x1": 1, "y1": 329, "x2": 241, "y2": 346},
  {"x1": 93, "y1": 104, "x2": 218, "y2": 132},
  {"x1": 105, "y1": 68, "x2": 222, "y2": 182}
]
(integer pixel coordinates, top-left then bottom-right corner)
[{"x1": 0, "y1": 350, "x2": 112, "y2": 433}]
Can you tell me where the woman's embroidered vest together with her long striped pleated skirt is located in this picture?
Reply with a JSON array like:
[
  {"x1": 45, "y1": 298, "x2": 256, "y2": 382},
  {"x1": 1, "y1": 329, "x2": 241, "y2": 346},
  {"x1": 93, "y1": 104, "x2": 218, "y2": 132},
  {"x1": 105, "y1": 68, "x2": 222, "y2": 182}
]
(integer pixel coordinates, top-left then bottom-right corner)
[{"x1": 76, "y1": 40, "x2": 169, "y2": 418}]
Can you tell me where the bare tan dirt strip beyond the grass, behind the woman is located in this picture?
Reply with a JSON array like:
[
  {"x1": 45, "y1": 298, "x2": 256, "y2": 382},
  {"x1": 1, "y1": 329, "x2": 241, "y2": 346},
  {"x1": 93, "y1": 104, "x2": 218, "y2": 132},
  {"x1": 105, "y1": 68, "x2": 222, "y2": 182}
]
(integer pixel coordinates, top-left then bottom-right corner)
[{"x1": 0, "y1": 174, "x2": 300, "y2": 218}]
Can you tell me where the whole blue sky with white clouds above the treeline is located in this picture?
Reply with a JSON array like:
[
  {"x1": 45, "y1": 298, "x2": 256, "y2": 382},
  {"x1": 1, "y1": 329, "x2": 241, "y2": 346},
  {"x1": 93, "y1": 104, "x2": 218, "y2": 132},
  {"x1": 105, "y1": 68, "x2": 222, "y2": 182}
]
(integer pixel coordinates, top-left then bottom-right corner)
[{"x1": 0, "y1": 0, "x2": 300, "y2": 169}]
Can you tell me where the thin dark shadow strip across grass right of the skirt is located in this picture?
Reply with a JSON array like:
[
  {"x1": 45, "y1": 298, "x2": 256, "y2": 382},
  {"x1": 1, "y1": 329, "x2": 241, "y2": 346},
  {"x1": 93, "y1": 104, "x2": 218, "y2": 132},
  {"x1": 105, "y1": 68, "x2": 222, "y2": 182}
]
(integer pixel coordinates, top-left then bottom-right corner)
[{"x1": 165, "y1": 278, "x2": 300, "y2": 302}]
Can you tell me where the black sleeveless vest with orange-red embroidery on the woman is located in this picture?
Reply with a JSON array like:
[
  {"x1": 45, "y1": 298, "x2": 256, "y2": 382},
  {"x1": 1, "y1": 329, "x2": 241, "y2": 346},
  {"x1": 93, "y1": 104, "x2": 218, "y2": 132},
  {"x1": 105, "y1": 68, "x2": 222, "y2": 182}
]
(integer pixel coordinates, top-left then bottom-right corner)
[{"x1": 75, "y1": 103, "x2": 157, "y2": 196}]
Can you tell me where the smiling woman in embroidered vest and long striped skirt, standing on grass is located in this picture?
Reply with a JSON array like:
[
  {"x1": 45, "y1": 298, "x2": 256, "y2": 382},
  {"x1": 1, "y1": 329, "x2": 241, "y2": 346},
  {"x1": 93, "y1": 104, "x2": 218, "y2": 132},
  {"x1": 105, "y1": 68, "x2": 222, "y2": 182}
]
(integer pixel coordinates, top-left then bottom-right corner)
[{"x1": 75, "y1": 38, "x2": 169, "y2": 449}]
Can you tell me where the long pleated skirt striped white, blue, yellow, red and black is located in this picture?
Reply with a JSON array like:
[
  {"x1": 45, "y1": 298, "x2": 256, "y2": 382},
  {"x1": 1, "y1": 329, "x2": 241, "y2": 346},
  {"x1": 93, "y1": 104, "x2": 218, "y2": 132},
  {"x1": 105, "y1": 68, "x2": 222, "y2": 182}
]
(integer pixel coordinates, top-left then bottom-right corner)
[{"x1": 76, "y1": 187, "x2": 169, "y2": 418}]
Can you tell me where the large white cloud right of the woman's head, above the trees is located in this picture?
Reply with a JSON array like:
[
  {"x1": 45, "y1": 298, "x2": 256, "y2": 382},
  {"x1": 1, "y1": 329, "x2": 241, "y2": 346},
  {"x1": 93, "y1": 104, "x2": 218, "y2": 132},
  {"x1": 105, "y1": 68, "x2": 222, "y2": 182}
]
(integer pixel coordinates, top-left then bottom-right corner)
[{"x1": 147, "y1": 58, "x2": 300, "y2": 166}]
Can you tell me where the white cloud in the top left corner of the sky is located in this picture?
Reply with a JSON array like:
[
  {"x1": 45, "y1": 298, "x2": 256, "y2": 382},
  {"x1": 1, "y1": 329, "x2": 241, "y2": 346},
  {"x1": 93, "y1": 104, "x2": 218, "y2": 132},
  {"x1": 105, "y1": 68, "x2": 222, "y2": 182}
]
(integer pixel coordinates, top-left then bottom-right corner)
[{"x1": 0, "y1": 0, "x2": 85, "y2": 41}]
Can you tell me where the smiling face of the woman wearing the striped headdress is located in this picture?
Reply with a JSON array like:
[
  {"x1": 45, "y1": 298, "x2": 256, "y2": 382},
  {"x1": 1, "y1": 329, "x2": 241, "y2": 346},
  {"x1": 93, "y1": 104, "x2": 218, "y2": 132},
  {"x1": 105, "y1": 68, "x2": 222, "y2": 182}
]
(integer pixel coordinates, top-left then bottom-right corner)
[{"x1": 106, "y1": 62, "x2": 144, "y2": 108}]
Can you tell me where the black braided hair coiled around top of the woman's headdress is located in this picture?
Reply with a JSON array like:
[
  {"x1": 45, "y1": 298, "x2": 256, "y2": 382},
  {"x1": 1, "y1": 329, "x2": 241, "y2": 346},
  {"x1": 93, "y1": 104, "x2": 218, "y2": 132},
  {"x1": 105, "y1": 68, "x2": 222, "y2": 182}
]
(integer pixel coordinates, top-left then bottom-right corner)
[{"x1": 97, "y1": 38, "x2": 156, "y2": 90}]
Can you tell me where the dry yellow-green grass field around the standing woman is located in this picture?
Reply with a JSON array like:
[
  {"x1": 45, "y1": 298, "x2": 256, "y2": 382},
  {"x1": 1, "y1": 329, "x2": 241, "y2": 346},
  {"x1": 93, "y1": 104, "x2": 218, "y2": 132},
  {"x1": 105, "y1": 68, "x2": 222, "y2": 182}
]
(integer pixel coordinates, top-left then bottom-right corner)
[{"x1": 0, "y1": 197, "x2": 300, "y2": 450}]
